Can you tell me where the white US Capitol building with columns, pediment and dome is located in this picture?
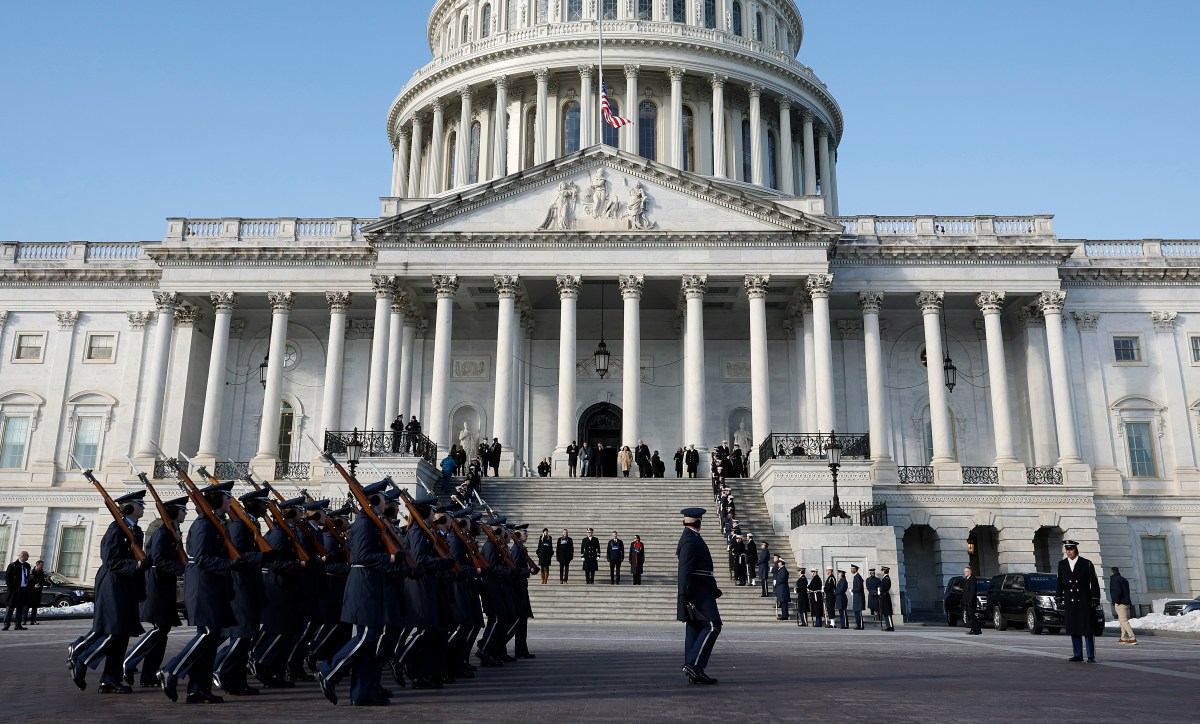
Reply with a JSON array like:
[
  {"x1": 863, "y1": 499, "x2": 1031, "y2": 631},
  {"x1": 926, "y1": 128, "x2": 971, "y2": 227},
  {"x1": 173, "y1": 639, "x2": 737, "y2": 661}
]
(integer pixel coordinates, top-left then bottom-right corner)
[{"x1": 0, "y1": 0, "x2": 1200, "y2": 612}]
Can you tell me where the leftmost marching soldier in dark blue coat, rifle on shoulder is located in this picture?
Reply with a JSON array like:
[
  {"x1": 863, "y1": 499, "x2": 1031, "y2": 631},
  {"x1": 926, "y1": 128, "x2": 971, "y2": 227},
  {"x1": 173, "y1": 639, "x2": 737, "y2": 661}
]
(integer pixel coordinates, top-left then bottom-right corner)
[{"x1": 67, "y1": 490, "x2": 149, "y2": 694}]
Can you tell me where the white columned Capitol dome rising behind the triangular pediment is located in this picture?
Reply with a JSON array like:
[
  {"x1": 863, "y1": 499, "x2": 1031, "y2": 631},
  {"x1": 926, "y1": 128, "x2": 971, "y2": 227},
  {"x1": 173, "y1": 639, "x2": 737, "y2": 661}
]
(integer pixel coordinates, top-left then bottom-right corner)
[{"x1": 386, "y1": 0, "x2": 842, "y2": 215}]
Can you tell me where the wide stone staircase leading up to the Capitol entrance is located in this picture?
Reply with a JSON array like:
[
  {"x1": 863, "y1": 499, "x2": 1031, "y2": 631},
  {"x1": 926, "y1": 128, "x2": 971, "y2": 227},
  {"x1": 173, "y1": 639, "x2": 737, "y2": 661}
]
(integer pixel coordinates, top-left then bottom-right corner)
[{"x1": 468, "y1": 478, "x2": 794, "y2": 623}]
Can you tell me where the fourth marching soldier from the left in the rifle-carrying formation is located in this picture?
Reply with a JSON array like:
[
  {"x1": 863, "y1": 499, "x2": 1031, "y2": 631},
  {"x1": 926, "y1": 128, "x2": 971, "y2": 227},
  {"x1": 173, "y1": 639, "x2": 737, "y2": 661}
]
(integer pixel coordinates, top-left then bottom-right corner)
[{"x1": 214, "y1": 487, "x2": 275, "y2": 696}]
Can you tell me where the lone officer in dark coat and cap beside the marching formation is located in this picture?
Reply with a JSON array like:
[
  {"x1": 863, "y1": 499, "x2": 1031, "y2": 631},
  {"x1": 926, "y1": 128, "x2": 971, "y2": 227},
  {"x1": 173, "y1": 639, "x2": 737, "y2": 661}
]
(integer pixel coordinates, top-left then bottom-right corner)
[{"x1": 676, "y1": 508, "x2": 721, "y2": 684}]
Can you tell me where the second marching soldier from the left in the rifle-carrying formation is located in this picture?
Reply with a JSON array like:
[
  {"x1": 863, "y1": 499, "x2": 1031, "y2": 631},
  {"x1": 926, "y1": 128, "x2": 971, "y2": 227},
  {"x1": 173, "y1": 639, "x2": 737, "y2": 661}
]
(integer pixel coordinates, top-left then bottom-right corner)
[{"x1": 124, "y1": 497, "x2": 187, "y2": 689}]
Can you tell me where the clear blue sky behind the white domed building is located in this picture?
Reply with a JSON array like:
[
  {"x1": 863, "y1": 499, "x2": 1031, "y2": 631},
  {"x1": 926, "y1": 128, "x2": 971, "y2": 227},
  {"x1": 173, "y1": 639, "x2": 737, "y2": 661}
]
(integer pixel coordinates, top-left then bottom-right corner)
[{"x1": 0, "y1": 0, "x2": 1200, "y2": 240}]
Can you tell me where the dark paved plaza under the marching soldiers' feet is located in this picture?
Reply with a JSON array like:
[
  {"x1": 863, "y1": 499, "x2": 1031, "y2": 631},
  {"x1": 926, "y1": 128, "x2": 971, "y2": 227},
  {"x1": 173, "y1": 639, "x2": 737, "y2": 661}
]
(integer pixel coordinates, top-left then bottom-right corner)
[{"x1": 0, "y1": 621, "x2": 1200, "y2": 723}]
